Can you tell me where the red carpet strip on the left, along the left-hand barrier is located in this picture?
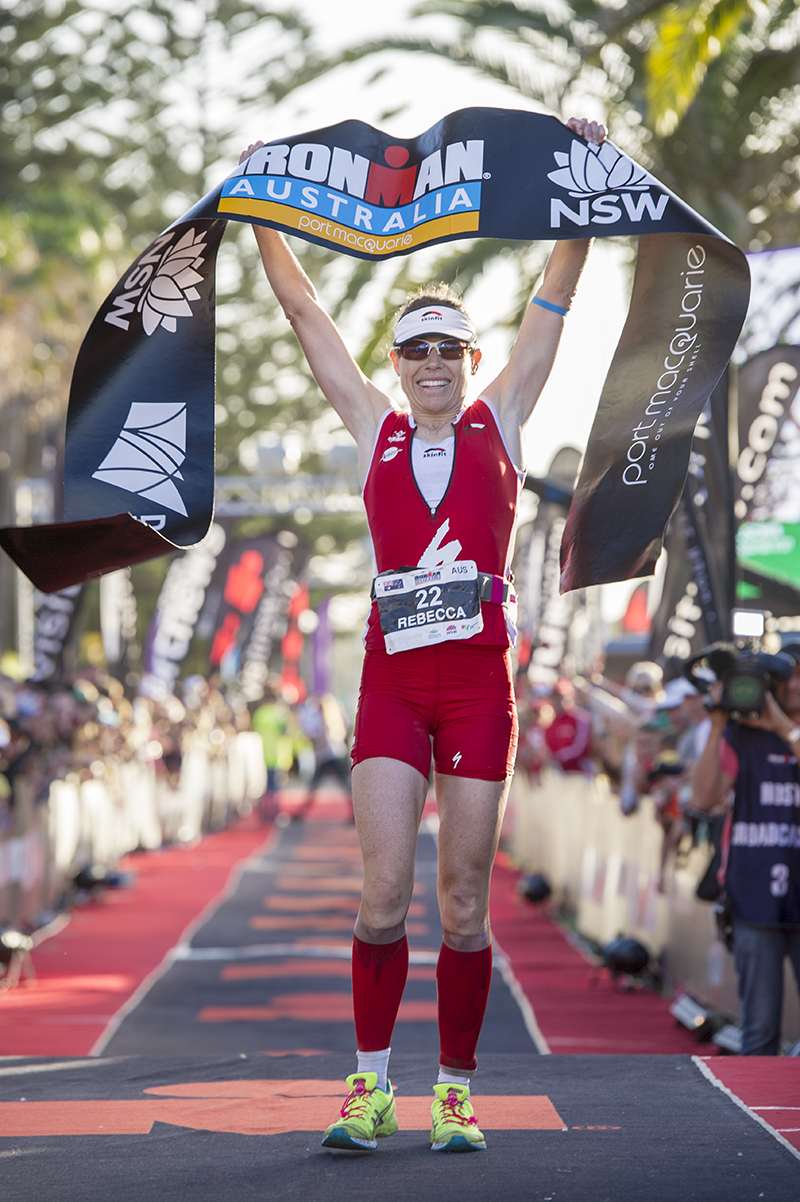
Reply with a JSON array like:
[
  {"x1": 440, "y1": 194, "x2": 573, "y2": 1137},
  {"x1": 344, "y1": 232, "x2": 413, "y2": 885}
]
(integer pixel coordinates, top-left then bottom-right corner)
[{"x1": 0, "y1": 819, "x2": 268, "y2": 1057}]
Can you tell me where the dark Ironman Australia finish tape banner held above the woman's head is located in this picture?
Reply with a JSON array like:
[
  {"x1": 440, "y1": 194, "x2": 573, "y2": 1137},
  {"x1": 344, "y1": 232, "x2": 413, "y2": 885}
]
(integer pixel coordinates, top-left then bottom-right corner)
[{"x1": 0, "y1": 108, "x2": 750, "y2": 591}]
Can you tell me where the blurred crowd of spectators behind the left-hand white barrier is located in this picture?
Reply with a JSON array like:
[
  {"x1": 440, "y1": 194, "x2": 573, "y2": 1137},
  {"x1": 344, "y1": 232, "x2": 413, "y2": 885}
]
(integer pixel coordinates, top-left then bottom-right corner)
[{"x1": 0, "y1": 670, "x2": 350, "y2": 839}]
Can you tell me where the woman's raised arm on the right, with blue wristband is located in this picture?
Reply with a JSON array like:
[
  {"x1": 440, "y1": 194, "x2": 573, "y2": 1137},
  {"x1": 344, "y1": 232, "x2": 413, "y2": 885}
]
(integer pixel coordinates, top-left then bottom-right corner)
[{"x1": 484, "y1": 117, "x2": 605, "y2": 430}]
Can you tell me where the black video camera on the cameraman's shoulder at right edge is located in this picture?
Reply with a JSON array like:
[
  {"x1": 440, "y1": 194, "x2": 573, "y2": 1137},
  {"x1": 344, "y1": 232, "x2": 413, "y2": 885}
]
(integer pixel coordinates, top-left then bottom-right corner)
[{"x1": 683, "y1": 643, "x2": 798, "y2": 719}]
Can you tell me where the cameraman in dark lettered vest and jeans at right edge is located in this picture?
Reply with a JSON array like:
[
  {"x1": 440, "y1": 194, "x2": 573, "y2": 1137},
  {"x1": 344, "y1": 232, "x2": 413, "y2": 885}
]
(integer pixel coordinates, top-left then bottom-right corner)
[{"x1": 692, "y1": 647, "x2": 800, "y2": 1055}]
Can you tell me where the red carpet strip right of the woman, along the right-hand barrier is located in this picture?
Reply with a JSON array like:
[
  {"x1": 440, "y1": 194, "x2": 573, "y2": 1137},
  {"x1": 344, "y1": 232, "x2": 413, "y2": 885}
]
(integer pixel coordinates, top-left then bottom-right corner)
[{"x1": 491, "y1": 852, "x2": 708, "y2": 1054}]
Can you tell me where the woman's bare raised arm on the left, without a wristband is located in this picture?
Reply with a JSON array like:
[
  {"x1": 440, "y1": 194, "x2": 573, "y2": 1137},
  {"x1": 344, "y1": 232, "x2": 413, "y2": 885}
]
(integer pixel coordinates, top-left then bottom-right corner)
[{"x1": 239, "y1": 142, "x2": 389, "y2": 446}]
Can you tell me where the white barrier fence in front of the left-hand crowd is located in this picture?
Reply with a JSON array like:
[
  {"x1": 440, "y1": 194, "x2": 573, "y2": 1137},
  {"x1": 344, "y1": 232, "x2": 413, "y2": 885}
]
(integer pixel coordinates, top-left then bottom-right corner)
[{"x1": 0, "y1": 731, "x2": 267, "y2": 927}]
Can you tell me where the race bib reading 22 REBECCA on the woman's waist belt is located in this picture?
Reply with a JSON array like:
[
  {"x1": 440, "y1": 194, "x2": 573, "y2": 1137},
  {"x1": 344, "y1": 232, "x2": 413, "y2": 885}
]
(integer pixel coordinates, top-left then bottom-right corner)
[{"x1": 372, "y1": 559, "x2": 513, "y2": 655}]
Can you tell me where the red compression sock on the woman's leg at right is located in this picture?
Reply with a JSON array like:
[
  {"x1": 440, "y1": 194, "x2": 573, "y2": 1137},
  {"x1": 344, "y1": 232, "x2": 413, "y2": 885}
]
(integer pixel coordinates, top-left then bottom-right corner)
[{"x1": 436, "y1": 944, "x2": 491, "y2": 1070}]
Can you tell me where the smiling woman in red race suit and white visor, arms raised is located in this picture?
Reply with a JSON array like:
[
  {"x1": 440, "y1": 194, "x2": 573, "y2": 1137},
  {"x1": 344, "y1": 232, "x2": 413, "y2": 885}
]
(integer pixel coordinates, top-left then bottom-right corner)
[{"x1": 241, "y1": 119, "x2": 605, "y2": 1152}]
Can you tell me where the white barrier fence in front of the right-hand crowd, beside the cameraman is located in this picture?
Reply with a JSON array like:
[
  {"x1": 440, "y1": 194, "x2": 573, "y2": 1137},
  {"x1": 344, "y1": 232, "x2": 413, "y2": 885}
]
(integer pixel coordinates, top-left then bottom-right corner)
[{"x1": 508, "y1": 769, "x2": 800, "y2": 1041}]
